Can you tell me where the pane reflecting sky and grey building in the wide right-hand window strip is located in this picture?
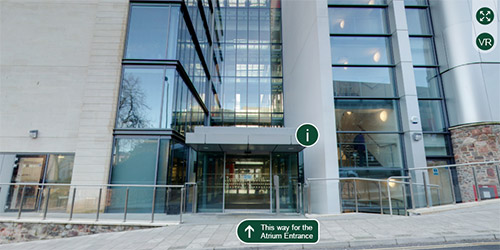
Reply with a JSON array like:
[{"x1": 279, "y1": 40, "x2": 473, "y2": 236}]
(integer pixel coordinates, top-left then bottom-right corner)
[{"x1": 332, "y1": 67, "x2": 394, "y2": 97}]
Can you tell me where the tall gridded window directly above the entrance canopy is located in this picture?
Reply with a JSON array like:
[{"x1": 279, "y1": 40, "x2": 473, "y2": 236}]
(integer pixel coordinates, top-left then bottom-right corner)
[{"x1": 216, "y1": 0, "x2": 283, "y2": 127}]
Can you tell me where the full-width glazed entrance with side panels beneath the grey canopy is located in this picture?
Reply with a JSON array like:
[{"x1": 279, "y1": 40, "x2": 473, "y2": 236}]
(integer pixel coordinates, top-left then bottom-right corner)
[{"x1": 195, "y1": 152, "x2": 303, "y2": 213}]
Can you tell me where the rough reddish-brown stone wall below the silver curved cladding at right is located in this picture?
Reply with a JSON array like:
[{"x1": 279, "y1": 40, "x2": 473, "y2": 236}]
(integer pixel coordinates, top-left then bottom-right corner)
[{"x1": 450, "y1": 123, "x2": 500, "y2": 202}]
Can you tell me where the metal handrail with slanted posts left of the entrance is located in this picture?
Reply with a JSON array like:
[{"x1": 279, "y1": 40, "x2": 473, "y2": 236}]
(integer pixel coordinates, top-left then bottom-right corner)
[{"x1": 0, "y1": 182, "x2": 188, "y2": 223}]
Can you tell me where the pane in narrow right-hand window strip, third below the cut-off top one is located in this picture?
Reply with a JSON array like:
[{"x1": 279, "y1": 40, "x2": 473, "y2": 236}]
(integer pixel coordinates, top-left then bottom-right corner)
[{"x1": 414, "y1": 68, "x2": 441, "y2": 98}]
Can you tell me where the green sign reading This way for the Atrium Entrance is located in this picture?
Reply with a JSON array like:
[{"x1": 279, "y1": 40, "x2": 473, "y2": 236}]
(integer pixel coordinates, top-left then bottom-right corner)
[{"x1": 236, "y1": 219, "x2": 319, "y2": 244}]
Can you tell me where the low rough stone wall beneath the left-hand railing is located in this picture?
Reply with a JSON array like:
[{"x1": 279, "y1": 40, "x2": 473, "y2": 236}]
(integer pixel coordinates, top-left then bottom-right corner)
[{"x1": 0, "y1": 222, "x2": 151, "y2": 244}]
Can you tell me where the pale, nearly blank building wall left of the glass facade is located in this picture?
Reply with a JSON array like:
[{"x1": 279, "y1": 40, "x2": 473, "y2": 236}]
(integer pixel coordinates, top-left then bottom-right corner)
[{"x1": 0, "y1": 0, "x2": 128, "y2": 197}]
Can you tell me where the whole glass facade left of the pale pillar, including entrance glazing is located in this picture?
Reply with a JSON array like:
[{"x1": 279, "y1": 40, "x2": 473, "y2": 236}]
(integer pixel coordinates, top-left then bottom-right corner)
[{"x1": 107, "y1": 0, "x2": 290, "y2": 215}]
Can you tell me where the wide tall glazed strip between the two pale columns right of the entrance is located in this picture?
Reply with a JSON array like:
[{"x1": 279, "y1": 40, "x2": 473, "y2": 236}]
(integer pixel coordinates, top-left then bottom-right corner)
[{"x1": 328, "y1": 0, "x2": 404, "y2": 178}]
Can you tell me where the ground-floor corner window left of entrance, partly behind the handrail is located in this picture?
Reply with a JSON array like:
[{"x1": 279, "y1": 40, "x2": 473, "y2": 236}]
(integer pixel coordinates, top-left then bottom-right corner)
[{"x1": 106, "y1": 137, "x2": 187, "y2": 213}]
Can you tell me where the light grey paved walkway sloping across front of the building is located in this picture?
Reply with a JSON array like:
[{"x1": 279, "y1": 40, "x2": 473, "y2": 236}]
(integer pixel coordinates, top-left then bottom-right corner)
[{"x1": 0, "y1": 200, "x2": 500, "y2": 250}]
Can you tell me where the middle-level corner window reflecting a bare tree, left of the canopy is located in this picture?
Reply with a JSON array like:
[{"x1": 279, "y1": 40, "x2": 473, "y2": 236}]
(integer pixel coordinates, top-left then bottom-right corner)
[{"x1": 116, "y1": 66, "x2": 205, "y2": 133}]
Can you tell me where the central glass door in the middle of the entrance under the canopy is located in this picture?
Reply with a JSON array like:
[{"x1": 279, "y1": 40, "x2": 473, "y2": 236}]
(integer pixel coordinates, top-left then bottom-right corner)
[{"x1": 224, "y1": 155, "x2": 271, "y2": 209}]
